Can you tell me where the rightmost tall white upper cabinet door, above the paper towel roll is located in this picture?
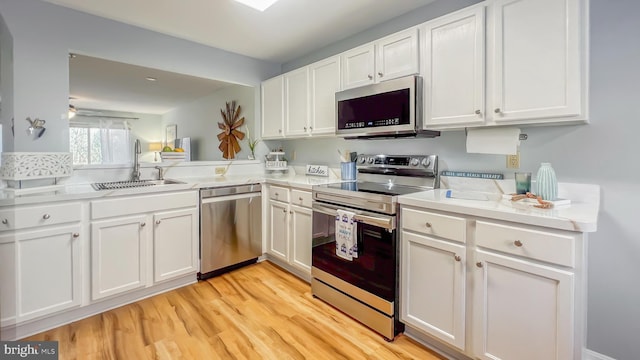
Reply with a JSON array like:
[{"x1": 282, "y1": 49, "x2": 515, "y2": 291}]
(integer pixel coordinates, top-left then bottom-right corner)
[{"x1": 489, "y1": 0, "x2": 583, "y2": 122}]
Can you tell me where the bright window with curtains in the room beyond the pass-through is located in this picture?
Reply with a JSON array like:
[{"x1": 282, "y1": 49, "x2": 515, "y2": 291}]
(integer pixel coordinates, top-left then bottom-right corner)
[{"x1": 69, "y1": 118, "x2": 131, "y2": 165}]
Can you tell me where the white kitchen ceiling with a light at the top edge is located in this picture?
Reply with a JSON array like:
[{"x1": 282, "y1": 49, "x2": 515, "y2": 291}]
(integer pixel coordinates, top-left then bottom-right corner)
[{"x1": 44, "y1": 0, "x2": 435, "y2": 63}]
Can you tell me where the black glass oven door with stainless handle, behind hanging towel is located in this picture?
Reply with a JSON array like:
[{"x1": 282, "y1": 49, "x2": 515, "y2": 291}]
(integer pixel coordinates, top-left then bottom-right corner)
[{"x1": 311, "y1": 202, "x2": 397, "y2": 302}]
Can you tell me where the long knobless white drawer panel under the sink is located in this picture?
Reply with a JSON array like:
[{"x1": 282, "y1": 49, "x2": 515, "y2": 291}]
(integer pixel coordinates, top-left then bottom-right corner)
[{"x1": 91, "y1": 191, "x2": 198, "y2": 220}]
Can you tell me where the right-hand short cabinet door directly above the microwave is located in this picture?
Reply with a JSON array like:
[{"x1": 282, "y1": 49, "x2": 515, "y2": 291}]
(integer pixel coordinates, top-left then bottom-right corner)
[{"x1": 375, "y1": 28, "x2": 420, "y2": 81}]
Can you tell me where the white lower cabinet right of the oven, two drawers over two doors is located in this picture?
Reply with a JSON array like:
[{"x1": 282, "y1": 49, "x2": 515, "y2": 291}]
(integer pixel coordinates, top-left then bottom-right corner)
[{"x1": 400, "y1": 205, "x2": 586, "y2": 360}]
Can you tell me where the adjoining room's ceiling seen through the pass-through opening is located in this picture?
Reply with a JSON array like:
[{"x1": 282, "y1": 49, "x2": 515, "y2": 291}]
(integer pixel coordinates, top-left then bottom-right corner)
[{"x1": 69, "y1": 55, "x2": 235, "y2": 115}]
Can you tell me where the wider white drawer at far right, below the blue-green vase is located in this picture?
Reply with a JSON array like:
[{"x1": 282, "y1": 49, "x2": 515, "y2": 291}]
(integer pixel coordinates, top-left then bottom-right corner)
[{"x1": 476, "y1": 221, "x2": 576, "y2": 267}]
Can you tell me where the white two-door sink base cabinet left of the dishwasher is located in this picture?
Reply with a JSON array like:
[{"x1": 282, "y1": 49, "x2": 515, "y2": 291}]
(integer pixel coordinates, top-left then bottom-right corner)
[{"x1": 91, "y1": 191, "x2": 199, "y2": 300}]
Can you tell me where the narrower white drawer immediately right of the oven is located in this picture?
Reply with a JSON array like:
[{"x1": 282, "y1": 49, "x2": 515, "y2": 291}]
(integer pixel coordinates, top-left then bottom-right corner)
[{"x1": 401, "y1": 208, "x2": 467, "y2": 243}]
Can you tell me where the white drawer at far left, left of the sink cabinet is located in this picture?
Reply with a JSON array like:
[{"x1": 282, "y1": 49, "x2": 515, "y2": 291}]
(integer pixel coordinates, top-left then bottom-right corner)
[{"x1": 0, "y1": 203, "x2": 82, "y2": 230}]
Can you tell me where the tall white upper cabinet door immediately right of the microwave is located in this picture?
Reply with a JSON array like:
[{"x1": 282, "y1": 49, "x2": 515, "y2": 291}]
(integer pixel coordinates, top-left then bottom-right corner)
[{"x1": 423, "y1": 5, "x2": 485, "y2": 128}]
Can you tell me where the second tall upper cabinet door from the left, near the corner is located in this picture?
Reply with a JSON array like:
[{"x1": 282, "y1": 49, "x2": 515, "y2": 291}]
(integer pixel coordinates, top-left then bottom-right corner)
[{"x1": 284, "y1": 67, "x2": 309, "y2": 137}]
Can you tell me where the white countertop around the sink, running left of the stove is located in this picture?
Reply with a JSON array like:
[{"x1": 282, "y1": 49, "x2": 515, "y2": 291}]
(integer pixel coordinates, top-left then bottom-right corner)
[{"x1": 0, "y1": 174, "x2": 341, "y2": 206}]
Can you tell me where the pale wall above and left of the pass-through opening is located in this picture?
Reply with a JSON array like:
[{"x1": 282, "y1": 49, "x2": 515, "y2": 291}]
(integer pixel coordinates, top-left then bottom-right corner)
[{"x1": 0, "y1": 0, "x2": 280, "y2": 151}]
